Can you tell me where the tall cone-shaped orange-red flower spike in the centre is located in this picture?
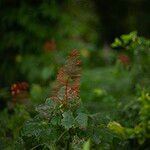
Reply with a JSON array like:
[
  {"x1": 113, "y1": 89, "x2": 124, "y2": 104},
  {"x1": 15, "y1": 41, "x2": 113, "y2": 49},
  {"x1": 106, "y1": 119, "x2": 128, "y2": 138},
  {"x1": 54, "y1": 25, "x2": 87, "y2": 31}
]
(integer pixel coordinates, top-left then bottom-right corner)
[{"x1": 51, "y1": 50, "x2": 81, "y2": 106}]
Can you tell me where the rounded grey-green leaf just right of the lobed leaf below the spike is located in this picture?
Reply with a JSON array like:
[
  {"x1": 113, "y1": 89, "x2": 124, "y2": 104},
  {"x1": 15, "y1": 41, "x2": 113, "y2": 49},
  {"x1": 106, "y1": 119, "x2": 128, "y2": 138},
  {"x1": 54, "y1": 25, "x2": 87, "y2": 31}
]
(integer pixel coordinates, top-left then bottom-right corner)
[{"x1": 76, "y1": 113, "x2": 88, "y2": 128}]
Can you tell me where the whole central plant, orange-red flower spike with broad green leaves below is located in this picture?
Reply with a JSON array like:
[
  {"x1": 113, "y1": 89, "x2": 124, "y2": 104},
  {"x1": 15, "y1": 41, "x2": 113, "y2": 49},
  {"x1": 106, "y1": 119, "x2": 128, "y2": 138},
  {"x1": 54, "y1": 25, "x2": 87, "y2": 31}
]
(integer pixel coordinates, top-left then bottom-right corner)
[{"x1": 19, "y1": 51, "x2": 88, "y2": 149}]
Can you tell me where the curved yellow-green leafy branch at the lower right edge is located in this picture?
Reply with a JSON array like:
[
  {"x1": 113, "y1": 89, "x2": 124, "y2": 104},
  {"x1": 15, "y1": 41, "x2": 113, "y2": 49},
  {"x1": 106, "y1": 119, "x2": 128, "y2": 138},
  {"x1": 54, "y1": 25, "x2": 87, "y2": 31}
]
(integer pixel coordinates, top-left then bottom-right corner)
[{"x1": 108, "y1": 92, "x2": 150, "y2": 145}]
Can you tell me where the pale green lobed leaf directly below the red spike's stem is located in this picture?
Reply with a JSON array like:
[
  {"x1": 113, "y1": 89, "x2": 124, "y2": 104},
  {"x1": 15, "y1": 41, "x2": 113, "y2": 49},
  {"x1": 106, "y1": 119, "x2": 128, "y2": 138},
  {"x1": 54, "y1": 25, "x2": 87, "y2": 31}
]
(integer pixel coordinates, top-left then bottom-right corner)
[{"x1": 61, "y1": 111, "x2": 75, "y2": 130}]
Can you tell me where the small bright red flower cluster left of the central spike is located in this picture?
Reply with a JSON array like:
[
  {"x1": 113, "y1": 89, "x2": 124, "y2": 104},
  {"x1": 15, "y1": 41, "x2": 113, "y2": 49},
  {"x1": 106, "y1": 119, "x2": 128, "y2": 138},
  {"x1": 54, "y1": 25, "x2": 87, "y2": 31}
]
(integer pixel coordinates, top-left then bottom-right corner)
[{"x1": 11, "y1": 82, "x2": 29, "y2": 96}]
